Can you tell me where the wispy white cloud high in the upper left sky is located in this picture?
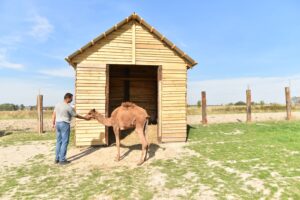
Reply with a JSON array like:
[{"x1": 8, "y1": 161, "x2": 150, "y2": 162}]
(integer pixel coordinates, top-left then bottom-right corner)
[{"x1": 28, "y1": 15, "x2": 54, "y2": 41}]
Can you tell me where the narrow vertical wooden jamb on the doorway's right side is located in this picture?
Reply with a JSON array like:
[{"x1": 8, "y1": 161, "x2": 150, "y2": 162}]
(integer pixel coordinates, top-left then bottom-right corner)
[{"x1": 157, "y1": 65, "x2": 162, "y2": 143}]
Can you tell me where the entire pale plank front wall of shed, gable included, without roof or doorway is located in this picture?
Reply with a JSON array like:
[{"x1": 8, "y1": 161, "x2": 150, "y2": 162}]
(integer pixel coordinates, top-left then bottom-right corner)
[{"x1": 72, "y1": 22, "x2": 186, "y2": 146}]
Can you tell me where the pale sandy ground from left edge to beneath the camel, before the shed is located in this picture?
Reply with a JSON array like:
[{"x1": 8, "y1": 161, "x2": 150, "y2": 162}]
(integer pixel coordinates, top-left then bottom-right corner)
[{"x1": 0, "y1": 141, "x2": 190, "y2": 171}]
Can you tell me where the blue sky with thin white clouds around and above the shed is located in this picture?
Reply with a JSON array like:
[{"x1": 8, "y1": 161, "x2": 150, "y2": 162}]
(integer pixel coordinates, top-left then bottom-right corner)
[{"x1": 0, "y1": 0, "x2": 300, "y2": 105}]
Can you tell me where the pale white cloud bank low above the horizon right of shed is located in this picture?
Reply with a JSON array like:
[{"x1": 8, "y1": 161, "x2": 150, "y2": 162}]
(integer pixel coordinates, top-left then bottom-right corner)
[{"x1": 188, "y1": 75, "x2": 300, "y2": 105}]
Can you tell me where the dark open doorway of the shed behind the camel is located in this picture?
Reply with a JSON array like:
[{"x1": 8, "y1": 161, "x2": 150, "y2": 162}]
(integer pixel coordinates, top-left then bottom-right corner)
[{"x1": 107, "y1": 65, "x2": 158, "y2": 145}]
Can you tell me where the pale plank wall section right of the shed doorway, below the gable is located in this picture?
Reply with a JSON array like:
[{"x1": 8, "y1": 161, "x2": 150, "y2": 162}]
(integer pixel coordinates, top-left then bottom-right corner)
[{"x1": 161, "y1": 64, "x2": 187, "y2": 142}]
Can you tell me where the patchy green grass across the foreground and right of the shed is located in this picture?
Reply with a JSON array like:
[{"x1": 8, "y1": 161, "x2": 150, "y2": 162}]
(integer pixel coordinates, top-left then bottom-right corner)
[{"x1": 0, "y1": 122, "x2": 300, "y2": 199}]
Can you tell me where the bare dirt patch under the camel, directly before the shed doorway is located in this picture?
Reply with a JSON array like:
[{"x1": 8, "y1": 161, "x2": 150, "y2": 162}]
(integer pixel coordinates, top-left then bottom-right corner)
[{"x1": 68, "y1": 143, "x2": 193, "y2": 170}]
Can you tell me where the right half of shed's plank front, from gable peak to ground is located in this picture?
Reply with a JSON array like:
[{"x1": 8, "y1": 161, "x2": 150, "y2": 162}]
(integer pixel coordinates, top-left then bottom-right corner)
[{"x1": 135, "y1": 24, "x2": 187, "y2": 142}]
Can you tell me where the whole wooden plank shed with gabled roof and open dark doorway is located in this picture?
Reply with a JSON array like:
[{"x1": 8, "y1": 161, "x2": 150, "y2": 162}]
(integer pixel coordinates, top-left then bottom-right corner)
[{"x1": 66, "y1": 13, "x2": 197, "y2": 146}]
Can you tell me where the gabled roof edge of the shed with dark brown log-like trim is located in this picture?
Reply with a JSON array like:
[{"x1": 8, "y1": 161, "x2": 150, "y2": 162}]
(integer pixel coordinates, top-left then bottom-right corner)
[{"x1": 65, "y1": 13, "x2": 197, "y2": 68}]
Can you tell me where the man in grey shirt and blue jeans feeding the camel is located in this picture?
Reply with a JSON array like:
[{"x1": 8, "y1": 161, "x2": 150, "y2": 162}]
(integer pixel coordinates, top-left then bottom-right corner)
[{"x1": 52, "y1": 93, "x2": 91, "y2": 165}]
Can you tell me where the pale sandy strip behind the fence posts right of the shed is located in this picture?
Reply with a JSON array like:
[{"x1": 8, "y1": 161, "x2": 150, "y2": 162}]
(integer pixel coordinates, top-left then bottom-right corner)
[{"x1": 187, "y1": 112, "x2": 300, "y2": 124}]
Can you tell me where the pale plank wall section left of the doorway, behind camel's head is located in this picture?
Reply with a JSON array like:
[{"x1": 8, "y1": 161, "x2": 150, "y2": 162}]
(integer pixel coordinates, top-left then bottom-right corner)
[{"x1": 75, "y1": 63, "x2": 106, "y2": 146}]
